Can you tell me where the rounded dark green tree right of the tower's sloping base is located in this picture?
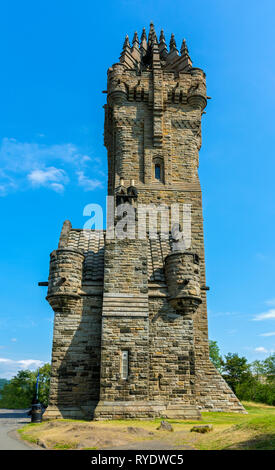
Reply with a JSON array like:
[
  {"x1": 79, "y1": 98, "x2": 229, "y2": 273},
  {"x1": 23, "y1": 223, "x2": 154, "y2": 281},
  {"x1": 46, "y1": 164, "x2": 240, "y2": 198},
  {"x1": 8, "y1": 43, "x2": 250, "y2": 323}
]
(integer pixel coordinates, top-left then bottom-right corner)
[{"x1": 222, "y1": 353, "x2": 252, "y2": 393}]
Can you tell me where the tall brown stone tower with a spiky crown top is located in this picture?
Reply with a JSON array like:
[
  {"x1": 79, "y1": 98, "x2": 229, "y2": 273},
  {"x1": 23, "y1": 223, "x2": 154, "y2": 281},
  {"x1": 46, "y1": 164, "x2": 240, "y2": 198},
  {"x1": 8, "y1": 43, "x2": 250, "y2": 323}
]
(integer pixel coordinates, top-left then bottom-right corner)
[{"x1": 43, "y1": 24, "x2": 244, "y2": 419}]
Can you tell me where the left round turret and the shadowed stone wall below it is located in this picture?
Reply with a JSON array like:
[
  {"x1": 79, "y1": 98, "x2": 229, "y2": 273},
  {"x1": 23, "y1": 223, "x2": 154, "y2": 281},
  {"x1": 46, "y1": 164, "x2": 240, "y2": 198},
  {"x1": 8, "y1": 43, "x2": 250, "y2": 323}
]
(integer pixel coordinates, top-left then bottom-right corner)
[{"x1": 44, "y1": 249, "x2": 102, "y2": 419}]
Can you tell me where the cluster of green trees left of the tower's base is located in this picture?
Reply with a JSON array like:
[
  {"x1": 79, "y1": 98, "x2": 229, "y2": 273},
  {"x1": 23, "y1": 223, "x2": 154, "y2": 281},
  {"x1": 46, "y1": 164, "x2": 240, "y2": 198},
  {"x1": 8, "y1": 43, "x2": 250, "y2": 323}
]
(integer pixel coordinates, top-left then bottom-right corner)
[{"x1": 0, "y1": 364, "x2": 50, "y2": 409}]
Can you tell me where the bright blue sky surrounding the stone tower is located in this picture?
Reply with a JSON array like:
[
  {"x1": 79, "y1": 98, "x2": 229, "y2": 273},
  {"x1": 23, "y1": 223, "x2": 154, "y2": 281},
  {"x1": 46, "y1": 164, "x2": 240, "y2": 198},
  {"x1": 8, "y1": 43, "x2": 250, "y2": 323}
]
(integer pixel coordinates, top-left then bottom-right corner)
[{"x1": 0, "y1": 0, "x2": 275, "y2": 378}]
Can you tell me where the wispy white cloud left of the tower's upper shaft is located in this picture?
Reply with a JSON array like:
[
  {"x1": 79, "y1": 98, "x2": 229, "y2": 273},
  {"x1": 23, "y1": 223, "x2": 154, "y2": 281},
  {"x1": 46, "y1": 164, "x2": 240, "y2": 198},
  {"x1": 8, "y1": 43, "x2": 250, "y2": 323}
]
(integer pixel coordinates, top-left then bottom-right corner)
[{"x1": 0, "y1": 138, "x2": 105, "y2": 196}]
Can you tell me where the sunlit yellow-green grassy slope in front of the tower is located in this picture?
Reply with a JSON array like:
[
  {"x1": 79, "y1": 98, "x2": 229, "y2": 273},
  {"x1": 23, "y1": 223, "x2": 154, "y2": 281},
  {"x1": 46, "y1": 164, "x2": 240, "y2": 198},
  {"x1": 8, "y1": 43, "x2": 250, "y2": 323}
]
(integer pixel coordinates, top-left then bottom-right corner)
[{"x1": 19, "y1": 403, "x2": 275, "y2": 450}]
